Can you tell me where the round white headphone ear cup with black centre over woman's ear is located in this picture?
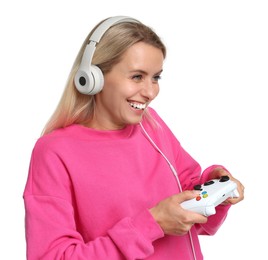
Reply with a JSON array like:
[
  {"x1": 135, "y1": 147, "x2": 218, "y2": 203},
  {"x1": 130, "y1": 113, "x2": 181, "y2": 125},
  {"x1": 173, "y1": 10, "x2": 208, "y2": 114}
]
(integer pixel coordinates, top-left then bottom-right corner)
[{"x1": 74, "y1": 65, "x2": 104, "y2": 95}]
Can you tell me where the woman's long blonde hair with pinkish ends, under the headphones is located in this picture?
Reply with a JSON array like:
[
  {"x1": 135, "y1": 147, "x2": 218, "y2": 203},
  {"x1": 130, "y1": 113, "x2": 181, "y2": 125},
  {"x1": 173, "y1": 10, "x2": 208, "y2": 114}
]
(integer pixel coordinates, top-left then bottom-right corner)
[{"x1": 42, "y1": 18, "x2": 166, "y2": 135}]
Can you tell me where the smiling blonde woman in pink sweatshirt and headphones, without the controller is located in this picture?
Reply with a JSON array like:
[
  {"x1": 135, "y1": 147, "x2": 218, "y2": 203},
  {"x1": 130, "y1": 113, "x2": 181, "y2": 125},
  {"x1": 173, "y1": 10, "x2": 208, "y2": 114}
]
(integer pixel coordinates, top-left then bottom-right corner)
[{"x1": 24, "y1": 17, "x2": 244, "y2": 260}]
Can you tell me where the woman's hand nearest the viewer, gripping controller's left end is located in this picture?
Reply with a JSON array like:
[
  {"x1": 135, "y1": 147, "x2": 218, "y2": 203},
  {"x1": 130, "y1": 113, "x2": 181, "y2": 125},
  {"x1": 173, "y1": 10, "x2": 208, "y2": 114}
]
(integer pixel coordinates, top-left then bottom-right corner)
[{"x1": 150, "y1": 191, "x2": 207, "y2": 235}]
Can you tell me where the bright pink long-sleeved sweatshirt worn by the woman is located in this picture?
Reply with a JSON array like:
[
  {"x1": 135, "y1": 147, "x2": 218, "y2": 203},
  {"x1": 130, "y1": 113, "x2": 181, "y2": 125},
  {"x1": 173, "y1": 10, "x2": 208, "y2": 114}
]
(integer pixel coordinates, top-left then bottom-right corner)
[{"x1": 24, "y1": 109, "x2": 229, "y2": 260}]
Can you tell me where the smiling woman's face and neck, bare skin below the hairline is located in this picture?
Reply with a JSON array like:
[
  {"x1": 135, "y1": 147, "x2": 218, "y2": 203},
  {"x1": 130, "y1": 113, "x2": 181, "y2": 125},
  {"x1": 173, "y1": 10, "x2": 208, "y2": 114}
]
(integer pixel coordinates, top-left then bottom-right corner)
[{"x1": 88, "y1": 42, "x2": 164, "y2": 130}]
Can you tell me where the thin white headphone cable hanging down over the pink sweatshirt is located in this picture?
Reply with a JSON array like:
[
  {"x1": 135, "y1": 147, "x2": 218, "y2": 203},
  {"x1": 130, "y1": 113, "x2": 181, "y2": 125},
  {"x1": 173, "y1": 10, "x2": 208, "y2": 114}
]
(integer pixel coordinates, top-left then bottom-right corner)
[{"x1": 139, "y1": 122, "x2": 197, "y2": 260}]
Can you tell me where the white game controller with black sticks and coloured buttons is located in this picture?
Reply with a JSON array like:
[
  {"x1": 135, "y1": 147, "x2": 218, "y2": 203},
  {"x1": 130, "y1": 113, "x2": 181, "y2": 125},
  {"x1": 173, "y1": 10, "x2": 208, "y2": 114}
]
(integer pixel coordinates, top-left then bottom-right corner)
[{"x1": 181, "y1": 176, "x2": 239, "y2": 217}]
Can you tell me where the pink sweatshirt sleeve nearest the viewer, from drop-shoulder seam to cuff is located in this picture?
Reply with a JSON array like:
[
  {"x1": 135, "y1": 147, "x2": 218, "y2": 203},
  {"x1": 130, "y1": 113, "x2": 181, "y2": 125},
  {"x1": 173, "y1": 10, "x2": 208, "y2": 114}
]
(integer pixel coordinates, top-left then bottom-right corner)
[{"x1": 25, "y1": 195, "x2": 164, "y2": 260}]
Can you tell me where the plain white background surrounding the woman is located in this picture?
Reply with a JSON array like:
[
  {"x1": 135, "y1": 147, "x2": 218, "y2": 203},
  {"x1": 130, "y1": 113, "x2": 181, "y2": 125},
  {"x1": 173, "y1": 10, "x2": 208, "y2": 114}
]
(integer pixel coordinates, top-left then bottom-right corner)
[{"x1": 0, "y1": 0, "x2": 268, "y2": 260}]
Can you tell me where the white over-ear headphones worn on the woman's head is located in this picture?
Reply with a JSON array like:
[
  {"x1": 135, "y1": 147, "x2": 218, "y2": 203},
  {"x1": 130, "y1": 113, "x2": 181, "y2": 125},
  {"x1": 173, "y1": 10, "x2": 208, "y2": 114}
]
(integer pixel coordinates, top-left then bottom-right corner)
[{"x1": 74, "y1": 16, "x2": 139, "y2": 95}]
